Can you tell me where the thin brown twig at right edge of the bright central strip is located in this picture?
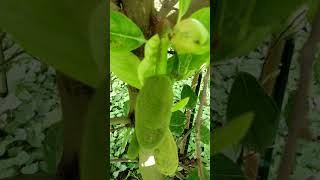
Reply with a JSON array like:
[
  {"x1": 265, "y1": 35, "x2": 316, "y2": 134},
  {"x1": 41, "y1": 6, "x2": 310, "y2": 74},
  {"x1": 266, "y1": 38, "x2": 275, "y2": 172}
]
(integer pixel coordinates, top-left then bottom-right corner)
[{"x1": 195, "y1": 68, "x2": 210, "y2": 180}]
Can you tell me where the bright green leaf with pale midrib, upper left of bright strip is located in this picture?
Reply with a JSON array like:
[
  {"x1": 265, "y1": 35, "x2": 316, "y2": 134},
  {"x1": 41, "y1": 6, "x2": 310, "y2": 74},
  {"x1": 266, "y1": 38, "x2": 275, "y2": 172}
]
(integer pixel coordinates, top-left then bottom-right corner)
[{"x1": 110, "y1": 11, "x2": 145, "y2": 51}]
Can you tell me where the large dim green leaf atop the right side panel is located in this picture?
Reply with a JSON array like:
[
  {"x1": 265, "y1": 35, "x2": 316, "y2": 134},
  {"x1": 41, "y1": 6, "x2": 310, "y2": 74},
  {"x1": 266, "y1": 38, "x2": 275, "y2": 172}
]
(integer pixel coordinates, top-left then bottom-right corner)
[{"x1": 213, "y1": 0, "x2": 303, "y2": 61}]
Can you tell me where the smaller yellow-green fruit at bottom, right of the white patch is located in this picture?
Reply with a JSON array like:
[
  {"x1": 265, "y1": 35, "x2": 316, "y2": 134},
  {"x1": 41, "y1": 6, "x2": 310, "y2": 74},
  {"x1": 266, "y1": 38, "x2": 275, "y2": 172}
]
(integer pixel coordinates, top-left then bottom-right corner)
[{"x1": 154, "y1": 129, "x2": 179, "y2": 176}]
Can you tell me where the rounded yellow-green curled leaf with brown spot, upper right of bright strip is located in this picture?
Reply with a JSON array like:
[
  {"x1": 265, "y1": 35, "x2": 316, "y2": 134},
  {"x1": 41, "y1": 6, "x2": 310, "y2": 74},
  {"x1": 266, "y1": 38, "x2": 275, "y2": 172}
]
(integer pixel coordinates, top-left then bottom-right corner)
[{"x1": 171, "y1": 18, "x2": 210, "y2": 54}]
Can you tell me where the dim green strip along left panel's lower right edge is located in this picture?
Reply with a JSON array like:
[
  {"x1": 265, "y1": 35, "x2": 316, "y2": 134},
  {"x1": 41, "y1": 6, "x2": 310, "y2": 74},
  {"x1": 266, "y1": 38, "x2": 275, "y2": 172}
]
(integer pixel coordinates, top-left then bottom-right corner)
[{"x1": 79, "y1": 82, "x2": 108, "y2": 180}]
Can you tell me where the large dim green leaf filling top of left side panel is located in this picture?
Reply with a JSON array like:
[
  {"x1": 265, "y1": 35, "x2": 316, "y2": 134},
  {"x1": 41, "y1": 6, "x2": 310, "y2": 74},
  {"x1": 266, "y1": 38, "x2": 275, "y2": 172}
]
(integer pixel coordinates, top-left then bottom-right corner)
[{"x1": 0, "y1": 0, "x2": 107, "y2": 87}]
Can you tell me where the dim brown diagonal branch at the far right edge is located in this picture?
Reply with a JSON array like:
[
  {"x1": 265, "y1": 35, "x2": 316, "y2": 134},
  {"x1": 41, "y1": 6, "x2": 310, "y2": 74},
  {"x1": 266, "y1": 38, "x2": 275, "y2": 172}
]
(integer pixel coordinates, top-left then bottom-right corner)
[{"x1": 277, "y1": 5, "x2": 320, "y2": 180}]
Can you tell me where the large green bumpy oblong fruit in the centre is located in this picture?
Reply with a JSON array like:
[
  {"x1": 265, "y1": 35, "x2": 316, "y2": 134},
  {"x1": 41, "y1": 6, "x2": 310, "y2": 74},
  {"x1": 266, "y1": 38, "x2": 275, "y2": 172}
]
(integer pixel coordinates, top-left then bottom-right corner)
[{"x1": 135, "y1": 75, "x2": 173, "y2": 149}]
